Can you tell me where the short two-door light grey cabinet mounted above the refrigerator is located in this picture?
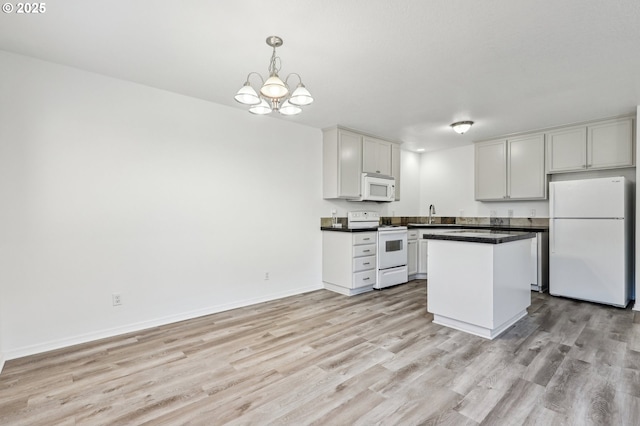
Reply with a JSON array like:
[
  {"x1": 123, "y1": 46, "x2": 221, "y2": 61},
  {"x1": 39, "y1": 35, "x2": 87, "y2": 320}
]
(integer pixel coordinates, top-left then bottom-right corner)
[{"x1": 546, "y1": 117, "x2": 634, "y2": 173}]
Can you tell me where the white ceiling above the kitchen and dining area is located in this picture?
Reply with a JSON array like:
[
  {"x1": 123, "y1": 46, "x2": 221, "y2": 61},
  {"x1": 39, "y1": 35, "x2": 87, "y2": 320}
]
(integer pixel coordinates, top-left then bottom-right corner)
[{"x1": 0, "y1": 0, "x2": 640, "y2": 150}]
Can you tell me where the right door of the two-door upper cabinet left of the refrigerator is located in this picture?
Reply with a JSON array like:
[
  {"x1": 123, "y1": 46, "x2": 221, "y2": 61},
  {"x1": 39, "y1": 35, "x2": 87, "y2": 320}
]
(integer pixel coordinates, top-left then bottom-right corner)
[{"x1": 507, "y1": 133, "x2": 547, "y2": 200}]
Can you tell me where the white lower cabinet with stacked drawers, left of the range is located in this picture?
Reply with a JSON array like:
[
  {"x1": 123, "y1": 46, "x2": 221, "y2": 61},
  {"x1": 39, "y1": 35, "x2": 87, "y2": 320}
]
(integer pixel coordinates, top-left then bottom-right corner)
[{"x1": 322, "y1": 231, "x2": 378, "y2": 296}]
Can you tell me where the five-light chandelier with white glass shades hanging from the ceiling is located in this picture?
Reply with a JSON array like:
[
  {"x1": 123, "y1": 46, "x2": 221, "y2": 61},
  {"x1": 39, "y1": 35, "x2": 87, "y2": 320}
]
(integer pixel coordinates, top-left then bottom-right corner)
[{"x1": 235, "y1": 36, "x2": 313, "y2": 115}]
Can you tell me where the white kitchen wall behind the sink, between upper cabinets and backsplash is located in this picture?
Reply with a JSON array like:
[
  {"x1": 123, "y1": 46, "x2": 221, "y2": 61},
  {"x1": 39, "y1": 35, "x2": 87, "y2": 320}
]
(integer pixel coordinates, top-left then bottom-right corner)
[{"x1": 420, "y1": 145, "x2": 549, "y2": 217}]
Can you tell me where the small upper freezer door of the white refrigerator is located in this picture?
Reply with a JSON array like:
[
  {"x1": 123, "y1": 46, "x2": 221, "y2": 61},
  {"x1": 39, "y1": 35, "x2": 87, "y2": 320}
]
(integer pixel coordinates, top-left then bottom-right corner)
[{"x1": 549, "y1": 177, "x2": 625, "y2": 218}]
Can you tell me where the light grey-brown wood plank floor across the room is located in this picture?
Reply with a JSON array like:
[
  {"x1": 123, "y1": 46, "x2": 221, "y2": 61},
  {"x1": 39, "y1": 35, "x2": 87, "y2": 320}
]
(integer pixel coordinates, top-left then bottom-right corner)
[{"x1": 0, "y1": 281, "x2": 640, "y2": 425}]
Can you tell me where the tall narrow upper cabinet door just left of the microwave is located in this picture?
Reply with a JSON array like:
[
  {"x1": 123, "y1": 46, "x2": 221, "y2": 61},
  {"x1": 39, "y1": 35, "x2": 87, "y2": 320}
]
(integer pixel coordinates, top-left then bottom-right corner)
[{"x1": 338, "y1": 130, "x2": 362, "y2": 198}]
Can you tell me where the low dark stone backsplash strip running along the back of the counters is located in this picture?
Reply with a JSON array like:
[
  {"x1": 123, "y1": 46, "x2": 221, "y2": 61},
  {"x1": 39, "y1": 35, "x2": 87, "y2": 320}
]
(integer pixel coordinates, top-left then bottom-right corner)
[{"x1": 320, "y1": 216, "x2": 549, "y2": 228}]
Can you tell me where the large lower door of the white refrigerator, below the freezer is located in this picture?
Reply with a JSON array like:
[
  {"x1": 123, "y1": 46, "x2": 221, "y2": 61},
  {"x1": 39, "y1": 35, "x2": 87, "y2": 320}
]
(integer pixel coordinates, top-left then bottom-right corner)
[{"x1": 549, "y1": 219, "x2": 629, "y2": 306}]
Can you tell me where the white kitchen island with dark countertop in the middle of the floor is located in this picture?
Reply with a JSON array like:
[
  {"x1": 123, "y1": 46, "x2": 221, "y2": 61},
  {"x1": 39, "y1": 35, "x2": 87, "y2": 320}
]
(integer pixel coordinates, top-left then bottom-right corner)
[{"x1": 424, "y1": 229, "x2": 536, "y2": 339}]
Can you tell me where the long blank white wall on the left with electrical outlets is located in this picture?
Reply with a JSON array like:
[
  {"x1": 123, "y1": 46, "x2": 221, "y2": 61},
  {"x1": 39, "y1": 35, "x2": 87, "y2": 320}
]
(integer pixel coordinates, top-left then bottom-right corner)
[{"x1": 0, "y1": 52, "x2": 329, "y2": 359}]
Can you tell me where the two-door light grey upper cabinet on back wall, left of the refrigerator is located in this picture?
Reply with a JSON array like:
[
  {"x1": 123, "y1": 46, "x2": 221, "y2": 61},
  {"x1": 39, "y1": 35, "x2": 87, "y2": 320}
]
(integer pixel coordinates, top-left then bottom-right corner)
[{"x1": 475, "y1": 134, "x2": 547, "y2": 201}]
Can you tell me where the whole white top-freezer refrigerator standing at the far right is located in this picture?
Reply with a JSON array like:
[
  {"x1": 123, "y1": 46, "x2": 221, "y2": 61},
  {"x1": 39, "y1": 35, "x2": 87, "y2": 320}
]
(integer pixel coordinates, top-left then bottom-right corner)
[{"x1": 549, "y1": 177, "x2": 632, "y2": 307}]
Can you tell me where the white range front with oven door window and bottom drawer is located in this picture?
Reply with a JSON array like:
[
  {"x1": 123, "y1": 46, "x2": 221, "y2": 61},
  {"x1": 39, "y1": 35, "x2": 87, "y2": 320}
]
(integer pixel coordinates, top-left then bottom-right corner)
[{"x1": 373, "y1": 226, "x2": 409, "y2": 289}]
